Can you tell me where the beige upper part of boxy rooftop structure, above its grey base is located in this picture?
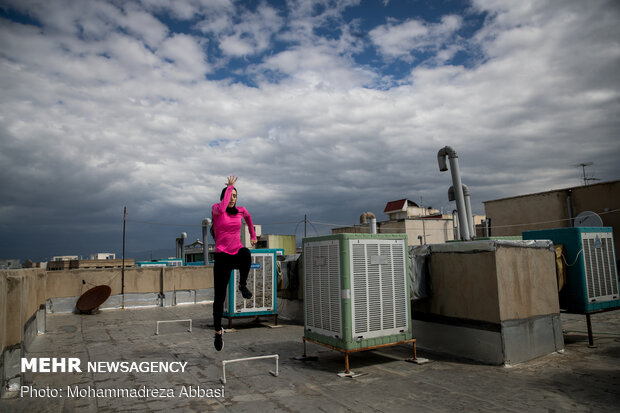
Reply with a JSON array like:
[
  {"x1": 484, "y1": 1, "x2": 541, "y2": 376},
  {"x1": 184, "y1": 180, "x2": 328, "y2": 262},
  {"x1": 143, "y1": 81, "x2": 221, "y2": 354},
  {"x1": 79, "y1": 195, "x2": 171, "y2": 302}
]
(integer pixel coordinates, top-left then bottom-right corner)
[{"x1": 414, "y1": 246, "x2": 560, "y2": 323}]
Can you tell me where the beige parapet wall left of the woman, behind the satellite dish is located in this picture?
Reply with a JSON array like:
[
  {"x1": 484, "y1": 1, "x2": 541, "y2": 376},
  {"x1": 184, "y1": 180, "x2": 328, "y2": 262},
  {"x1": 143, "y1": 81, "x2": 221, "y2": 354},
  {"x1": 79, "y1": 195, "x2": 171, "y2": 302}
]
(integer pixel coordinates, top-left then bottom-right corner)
[{"x1": 0, "y1": 266, "x2": 213, "y2": 394}]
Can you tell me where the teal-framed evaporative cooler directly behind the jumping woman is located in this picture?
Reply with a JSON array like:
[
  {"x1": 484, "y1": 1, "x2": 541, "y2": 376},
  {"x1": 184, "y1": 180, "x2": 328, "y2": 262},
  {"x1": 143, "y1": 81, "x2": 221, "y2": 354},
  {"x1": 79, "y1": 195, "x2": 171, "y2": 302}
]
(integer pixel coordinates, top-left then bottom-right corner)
[{"x1": 222, "y1": 249, "x2": 279, "y2": 328}]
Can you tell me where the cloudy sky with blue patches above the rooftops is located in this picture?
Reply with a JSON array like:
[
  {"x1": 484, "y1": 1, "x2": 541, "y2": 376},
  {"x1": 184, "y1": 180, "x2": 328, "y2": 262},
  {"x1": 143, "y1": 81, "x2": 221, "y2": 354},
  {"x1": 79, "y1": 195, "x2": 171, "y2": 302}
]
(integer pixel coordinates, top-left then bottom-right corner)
[{"x1": 0, "y1": 0, "x2": 620, "y2": 260}]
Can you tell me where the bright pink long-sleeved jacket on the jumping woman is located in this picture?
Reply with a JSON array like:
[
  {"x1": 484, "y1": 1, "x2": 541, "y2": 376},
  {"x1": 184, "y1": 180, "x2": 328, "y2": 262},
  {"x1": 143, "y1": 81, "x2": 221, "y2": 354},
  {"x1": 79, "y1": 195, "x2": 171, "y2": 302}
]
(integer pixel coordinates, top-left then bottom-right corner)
[{"x1": 211, "y1": 185, "x2": 256, "y2": 255}]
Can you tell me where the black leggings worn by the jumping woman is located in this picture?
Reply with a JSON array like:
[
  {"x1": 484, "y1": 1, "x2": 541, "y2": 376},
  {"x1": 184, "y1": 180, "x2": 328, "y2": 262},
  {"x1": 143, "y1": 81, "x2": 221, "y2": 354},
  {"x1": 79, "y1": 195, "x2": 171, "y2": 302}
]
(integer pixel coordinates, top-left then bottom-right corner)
[{"x1": 213, "y1": 248, "x2": 252, "y2": 331}]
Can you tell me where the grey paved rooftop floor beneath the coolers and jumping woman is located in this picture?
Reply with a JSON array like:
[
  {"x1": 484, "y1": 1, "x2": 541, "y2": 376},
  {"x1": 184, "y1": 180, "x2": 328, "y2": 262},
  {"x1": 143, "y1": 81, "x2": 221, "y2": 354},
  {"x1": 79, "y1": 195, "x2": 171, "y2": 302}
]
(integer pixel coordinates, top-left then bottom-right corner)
[{"x1": 0, "y1": 304, "x2": 620, "y2": 413}]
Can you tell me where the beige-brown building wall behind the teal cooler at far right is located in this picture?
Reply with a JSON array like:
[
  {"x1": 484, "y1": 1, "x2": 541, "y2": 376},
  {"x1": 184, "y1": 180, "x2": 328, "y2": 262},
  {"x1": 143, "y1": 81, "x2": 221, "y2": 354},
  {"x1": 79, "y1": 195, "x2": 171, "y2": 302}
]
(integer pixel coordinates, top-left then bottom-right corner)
[{"x1": 484, "y1": 180, "x2": 620, "y2": 258}]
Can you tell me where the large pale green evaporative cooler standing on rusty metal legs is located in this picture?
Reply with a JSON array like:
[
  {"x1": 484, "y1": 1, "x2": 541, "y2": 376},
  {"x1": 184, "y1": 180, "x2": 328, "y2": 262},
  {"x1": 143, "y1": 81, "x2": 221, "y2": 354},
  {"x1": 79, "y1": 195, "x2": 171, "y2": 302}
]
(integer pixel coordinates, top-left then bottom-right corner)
[{"x1": 303, "y1": 234, "x2": 412, "y2": 350}]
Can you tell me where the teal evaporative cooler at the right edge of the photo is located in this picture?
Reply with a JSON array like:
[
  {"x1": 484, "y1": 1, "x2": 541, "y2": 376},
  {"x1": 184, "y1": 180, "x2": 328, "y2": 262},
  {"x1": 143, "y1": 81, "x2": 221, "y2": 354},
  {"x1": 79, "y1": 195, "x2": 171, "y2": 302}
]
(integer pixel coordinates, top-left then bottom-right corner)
[{"x1": 523, "y1": 227, "x2": 620, "y2": 314}]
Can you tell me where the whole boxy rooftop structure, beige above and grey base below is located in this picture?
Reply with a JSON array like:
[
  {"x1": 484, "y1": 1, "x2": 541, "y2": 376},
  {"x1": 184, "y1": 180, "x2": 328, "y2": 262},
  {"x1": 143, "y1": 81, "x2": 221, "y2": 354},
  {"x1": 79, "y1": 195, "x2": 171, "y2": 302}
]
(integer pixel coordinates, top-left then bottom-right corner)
[{"x1": 412, "y1": 241, "x2": 564, "y2": 364}]
